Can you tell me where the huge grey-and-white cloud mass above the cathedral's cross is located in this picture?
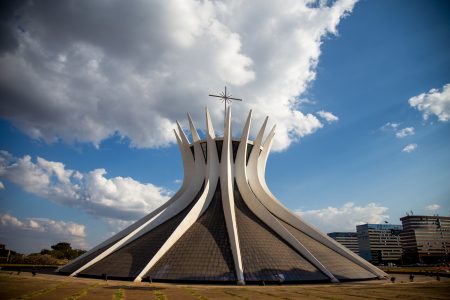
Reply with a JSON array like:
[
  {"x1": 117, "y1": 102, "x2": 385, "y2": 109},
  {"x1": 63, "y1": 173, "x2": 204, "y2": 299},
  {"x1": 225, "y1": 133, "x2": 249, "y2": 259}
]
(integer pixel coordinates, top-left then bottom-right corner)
[{"x1": 0, "y1": 0, "x2": 355, "y2": 150}]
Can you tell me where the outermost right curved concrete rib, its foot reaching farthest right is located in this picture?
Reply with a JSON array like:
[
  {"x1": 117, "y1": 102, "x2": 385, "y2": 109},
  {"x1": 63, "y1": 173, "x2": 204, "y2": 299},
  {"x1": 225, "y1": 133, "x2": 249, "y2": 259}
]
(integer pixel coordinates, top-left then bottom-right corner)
[{"x1": 247, "y1": 127, "x2": 388, "y2": 278}]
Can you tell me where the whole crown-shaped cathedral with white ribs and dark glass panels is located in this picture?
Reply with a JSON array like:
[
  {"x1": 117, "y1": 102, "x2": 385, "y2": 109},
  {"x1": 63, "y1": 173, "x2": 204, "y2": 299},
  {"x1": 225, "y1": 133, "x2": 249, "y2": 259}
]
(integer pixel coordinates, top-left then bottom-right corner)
[{"x1": 58, "y1": 108, "x2": 387, "y2": 284}]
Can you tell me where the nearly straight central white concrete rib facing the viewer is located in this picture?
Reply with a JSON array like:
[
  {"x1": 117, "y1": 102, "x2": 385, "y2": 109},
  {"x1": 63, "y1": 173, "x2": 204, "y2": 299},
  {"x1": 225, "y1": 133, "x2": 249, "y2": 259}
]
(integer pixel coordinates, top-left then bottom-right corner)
[{"x1": 220, "y1": 107, "x2": 245, "y2": 285}]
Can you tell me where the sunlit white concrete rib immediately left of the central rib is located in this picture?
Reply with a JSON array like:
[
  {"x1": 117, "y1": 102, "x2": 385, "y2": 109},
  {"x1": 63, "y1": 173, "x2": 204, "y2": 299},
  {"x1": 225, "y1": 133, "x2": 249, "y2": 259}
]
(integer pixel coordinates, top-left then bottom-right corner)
[{"x1": 134, "y1": 109, "x2": 219, "y2": 282}]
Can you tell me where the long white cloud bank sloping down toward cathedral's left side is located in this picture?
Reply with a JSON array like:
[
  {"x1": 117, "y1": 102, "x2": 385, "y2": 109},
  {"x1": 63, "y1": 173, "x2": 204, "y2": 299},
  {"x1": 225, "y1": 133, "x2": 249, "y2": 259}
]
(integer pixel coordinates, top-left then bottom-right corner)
[{"x1": 0, "y1": 151, "x2": 170, "y2": 220}]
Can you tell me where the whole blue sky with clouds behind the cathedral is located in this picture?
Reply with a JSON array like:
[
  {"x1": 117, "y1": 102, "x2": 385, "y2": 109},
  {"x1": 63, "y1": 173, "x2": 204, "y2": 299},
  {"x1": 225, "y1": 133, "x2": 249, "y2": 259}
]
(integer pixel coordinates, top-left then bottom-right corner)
[{"x1": 0, "y1": 1, "x2": 450, "y2": 252}]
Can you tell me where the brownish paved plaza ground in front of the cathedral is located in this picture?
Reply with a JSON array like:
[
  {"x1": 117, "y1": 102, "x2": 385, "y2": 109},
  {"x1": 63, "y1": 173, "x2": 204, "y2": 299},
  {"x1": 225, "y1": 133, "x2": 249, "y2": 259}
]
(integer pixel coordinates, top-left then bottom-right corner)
[{"x1": 0, "y1": 271, "x2": 450, "y2": 300}]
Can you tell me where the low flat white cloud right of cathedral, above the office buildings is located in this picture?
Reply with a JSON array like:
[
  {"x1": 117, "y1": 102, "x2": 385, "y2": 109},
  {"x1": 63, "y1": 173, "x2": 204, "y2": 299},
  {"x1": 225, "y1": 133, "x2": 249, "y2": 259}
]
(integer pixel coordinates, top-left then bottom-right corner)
[{"x1": 296, "y1": 202, "x2": 389, "y2": 232}]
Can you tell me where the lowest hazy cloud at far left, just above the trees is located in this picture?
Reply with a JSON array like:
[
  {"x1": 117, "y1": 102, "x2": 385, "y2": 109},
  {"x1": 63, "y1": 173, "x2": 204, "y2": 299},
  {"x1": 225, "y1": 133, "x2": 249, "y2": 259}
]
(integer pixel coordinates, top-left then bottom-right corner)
[{"x1": 0, "y1": 214, "x2": 88, "y2": 252}]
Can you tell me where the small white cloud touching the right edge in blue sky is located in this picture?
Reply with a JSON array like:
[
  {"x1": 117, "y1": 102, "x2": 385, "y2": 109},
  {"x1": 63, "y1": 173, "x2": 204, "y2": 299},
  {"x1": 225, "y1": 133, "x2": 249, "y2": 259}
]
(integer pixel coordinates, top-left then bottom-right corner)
[{"x1": 408, "y1": 83, "x2": 450, "y2": 122}]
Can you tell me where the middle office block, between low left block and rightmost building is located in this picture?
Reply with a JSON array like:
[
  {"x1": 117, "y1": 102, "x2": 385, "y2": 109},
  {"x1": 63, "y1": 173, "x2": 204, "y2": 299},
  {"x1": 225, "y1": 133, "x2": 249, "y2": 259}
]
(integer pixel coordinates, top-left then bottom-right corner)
[{"x1": 356, "y1": 224, "x2": 402, "y2": 264}]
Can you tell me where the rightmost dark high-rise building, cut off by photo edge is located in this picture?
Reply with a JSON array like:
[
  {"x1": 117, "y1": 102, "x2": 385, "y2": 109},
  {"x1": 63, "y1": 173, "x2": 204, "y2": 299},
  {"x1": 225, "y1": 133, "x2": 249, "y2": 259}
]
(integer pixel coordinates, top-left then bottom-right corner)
[{"x1": 400, "y1": 215, "x2": 450, "y2": 263}]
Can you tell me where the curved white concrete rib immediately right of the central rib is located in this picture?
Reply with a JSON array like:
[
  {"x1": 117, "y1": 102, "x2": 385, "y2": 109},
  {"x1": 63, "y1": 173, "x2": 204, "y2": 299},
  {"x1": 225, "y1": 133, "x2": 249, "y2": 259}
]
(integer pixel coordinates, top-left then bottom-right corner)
[{"x1": 235, "y1": 112, "x2": 339, "y2": 282}]
